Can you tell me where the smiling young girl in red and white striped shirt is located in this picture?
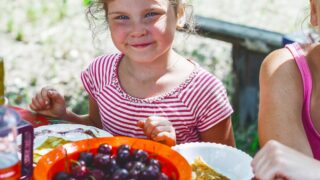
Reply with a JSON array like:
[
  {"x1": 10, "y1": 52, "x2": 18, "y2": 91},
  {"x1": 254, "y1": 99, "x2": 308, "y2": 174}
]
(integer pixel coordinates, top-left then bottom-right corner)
[{"x1": 30, "y1": 0, "x2": 234, "y2": 146}]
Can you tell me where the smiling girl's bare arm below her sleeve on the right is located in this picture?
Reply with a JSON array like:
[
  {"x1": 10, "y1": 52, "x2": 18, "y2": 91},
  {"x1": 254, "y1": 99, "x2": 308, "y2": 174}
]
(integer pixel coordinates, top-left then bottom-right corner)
[{"x1": 200, "y1": 117, "x2": 235, "y2": 147}]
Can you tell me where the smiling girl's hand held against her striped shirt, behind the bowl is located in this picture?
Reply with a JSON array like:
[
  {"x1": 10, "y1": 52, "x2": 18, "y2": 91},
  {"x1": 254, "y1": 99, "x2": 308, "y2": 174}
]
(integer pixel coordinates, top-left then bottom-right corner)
[{"x1": 138, "y1": 116, "x2": 176, "y2": 146}]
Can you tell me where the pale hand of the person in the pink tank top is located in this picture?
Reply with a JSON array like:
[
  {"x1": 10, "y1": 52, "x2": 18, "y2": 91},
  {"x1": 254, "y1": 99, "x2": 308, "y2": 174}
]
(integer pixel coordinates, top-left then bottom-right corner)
[{"x1": 251, "y1": 140, "x2": 320, "y2": 179}]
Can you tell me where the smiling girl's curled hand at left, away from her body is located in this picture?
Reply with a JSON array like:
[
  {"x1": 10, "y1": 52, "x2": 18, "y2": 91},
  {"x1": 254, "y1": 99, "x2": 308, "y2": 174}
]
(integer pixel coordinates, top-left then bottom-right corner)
[{"x1": 29, "y1": 87, "x2": 67, "y2": 119}]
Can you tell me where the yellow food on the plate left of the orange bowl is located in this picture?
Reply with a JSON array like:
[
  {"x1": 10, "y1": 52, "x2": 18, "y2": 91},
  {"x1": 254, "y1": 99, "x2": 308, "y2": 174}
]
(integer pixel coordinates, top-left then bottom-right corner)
[{"x1": 33, "y1": 136, "x2": 71, "y2": 164}]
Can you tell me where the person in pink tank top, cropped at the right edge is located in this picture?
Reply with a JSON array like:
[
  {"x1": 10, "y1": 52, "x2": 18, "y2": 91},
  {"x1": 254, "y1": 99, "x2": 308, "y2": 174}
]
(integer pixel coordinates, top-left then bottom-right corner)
[{"x1": 252, "y1": 0, "x2": 320, "y2": 179}]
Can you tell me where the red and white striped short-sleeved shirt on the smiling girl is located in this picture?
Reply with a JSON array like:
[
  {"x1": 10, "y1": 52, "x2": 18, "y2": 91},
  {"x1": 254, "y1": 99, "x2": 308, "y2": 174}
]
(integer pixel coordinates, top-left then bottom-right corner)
[{"x1": 81, "y1": 54, "x2": 233, "y2": 144}]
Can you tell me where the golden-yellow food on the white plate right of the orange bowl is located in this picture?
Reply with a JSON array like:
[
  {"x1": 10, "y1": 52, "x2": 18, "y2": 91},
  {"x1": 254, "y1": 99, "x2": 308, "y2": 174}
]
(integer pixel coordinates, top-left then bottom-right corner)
[{"x1": 191, "y1": 156, "x2": 229, "y2": 180}]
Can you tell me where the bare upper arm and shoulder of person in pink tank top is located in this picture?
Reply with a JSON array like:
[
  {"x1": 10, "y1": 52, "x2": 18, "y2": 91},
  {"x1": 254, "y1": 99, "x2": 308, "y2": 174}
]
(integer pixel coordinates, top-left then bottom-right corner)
[{"x1": 258, "y1": 49, "x2": 311, "y2": 155}]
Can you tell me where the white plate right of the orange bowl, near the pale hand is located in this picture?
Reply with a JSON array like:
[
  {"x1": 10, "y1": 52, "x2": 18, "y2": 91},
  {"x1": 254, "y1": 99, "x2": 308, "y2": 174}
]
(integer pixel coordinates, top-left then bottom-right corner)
[{"x1": 172, "y1": 143, "x2": 253, "y2": 180}]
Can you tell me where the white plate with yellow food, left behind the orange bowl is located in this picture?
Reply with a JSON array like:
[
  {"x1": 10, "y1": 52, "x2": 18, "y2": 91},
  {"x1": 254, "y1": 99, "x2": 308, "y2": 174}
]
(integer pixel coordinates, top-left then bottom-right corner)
[{"x1": 17, "y1": 124, "x2": 112, "y2": 149}]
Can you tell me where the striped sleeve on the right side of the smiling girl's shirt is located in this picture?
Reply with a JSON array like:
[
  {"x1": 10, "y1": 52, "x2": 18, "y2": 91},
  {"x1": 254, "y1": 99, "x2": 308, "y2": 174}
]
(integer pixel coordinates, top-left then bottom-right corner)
[{"x1": 197, "y1": 73, "x2": 233, "y2": 132}]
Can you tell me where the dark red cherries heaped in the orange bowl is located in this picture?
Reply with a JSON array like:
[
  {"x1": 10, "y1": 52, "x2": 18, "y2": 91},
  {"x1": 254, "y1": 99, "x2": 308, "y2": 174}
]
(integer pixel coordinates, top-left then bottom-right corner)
[{"x1": 54, "y1": 144, "x2": 169, "y2": 180}]
